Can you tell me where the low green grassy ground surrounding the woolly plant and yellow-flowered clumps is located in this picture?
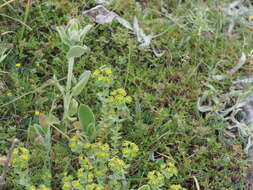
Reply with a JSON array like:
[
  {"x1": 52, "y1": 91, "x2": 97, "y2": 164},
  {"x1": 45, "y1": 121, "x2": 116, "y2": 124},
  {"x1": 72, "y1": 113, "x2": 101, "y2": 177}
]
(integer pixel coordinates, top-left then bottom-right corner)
[{"x1": 0, "y1": 0, "x2": 253, "y2": 190}]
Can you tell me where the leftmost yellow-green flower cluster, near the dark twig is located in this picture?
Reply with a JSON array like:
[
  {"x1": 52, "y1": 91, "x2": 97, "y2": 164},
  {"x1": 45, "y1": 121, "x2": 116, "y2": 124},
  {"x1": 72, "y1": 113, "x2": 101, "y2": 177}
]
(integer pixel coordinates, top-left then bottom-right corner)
[{"x1": 12, "y1": 147, "x2": 30, "y2": 169}]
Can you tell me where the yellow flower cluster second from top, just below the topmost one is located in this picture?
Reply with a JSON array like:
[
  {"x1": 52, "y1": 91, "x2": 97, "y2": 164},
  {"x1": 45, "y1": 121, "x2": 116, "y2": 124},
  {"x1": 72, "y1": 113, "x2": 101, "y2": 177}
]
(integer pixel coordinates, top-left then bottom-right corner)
[{"x1": 107, "y1": 88, "x2": 132, "y2": 105}]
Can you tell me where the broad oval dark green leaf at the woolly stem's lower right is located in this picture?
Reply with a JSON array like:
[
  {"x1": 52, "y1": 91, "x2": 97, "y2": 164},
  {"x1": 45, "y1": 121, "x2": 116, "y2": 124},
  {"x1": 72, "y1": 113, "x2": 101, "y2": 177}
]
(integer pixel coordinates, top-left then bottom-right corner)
[{"x1": 78, "y1": 104, "x2": 97, "y2": 140}]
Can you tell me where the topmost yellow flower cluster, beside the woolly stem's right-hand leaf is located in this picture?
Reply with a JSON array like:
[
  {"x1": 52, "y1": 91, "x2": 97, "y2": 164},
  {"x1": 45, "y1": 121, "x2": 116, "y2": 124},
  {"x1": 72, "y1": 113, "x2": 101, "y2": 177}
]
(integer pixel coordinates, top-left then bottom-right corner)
[{"x1": 93, "y1": 67, "x2": 112, "y2": 84}]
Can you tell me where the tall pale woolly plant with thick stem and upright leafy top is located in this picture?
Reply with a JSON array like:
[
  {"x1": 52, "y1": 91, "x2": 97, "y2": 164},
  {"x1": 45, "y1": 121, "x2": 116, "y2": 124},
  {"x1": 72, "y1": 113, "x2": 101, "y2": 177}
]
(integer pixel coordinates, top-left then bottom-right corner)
[{"x1": 54, "y1": 19, "x2": 92, "y2": 121}]
